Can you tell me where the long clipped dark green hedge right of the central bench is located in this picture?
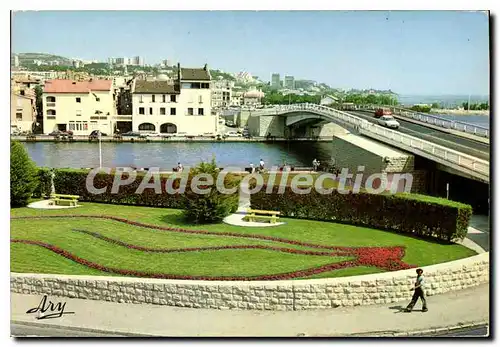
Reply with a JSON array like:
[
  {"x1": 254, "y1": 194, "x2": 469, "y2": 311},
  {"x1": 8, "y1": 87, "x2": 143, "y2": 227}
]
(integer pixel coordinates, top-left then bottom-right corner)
[{"x1": 251, "y1": 187, "x2": 472, "y2": 241}]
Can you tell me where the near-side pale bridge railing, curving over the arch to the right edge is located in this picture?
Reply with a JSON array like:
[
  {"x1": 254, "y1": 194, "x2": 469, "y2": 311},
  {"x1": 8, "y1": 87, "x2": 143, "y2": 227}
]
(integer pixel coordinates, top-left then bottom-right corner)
[{"x1": 252, "y1": 104, "x2": 490, "y2": 177}]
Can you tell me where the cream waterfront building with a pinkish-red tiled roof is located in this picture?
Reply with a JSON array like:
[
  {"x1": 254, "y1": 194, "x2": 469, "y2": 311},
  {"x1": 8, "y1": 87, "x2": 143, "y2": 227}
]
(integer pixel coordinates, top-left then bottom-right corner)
[{"x1": 43, "y1": 79, "x2": 115, "y2": 135}]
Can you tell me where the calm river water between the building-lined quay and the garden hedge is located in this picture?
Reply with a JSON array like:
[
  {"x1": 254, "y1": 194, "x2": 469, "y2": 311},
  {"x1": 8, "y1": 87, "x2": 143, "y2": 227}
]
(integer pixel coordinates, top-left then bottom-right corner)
[{"x1": 24, "y1": 142, "x2": 332, "y2": 170}]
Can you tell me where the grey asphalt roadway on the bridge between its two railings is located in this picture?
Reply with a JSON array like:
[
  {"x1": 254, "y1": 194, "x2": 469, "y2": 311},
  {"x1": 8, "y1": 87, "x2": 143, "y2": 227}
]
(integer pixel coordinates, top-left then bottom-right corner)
[{"x1": 347, "y1": 111, "x2": 490, "y2": 160}]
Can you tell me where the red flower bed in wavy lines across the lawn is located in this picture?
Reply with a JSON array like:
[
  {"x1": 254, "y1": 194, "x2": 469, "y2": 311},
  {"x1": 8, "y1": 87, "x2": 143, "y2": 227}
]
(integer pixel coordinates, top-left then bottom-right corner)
[{"x1": 11, "y1": 215, "x2": 415, "y2": 281}]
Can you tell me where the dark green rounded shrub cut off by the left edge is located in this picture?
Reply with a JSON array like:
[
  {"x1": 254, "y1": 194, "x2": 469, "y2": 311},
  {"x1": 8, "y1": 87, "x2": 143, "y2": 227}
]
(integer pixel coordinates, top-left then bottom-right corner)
[{"x1": 10, "y1": 141, "x2": 37, "y2": 207}]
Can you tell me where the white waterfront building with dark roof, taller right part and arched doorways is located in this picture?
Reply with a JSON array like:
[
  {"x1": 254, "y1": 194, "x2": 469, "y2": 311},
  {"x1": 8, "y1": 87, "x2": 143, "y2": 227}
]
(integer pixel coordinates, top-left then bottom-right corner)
[{"x1": 132, "y1": 64, "x2": 217, "y2": 135}]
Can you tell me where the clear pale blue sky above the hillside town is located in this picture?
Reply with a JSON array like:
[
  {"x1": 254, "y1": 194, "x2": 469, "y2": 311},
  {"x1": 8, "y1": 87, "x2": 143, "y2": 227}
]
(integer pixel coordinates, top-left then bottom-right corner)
[{"x1": 12, "y1": 11, "x2": 489, "y2": 95}]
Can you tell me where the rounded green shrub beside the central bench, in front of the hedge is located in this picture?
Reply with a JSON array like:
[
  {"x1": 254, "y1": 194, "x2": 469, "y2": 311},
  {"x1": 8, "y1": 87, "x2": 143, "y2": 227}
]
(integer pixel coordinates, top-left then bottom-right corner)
[{"x1": 184, "y1": 159, "x2": 238, "y2": 224}]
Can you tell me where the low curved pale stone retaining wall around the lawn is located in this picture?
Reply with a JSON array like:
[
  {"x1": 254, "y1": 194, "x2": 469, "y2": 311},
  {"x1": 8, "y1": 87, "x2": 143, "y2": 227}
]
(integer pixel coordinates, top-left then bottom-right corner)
[{"x1": 10, "y1": 253, "x2": 489, "y2": 310}]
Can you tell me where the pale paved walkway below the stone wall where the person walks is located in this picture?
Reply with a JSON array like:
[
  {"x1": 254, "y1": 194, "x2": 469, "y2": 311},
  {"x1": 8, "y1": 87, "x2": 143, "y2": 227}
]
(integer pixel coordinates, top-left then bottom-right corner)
[{"x1": 11, "y1": 284, "x2": 489, "y2": 337}]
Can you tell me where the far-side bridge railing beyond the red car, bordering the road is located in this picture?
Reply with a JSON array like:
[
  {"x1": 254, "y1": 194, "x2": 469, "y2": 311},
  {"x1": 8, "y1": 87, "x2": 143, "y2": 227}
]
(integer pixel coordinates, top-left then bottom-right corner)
[{"x1": 364, "y1": 105, "x2": 490, "y2": 138}]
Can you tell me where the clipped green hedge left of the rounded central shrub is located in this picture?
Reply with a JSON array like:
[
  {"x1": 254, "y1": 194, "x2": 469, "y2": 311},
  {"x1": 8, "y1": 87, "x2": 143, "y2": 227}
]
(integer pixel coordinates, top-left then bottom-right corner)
[{"x1": 54, "y1": 169, "x2": 239, "y2": 209}]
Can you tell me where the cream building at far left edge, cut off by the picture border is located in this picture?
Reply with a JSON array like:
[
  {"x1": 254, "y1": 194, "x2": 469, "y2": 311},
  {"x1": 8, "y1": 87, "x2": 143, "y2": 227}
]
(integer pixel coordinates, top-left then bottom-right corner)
[{"x1": 10, "y1": 89, "x2": 36, "y2": 132}]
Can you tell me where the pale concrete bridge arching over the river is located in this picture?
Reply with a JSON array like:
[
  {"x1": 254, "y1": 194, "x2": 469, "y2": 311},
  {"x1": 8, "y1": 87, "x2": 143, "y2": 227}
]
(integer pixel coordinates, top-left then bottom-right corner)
[{"x1": 249, "y1": 104, "x2": 490, "y2": 183}]
